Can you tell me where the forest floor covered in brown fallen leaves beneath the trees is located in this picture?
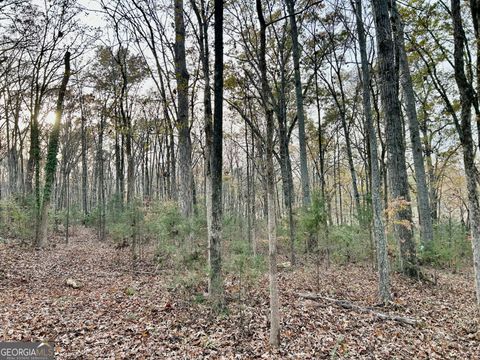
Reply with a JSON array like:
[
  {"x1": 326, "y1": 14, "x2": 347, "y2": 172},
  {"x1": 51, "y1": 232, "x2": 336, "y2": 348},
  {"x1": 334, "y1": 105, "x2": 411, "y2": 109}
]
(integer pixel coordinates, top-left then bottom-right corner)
[{"x1": 0, "y1": 228, "x2": 480, "y2": 359}]
